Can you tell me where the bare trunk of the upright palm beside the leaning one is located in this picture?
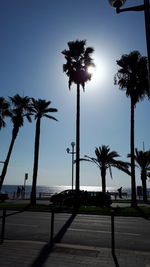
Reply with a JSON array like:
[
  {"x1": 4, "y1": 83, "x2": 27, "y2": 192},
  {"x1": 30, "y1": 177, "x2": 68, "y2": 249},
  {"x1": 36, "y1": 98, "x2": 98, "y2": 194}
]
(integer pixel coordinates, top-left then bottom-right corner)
[{"x1": 30, "y1": 118, "x2": 41, "y2": 205}]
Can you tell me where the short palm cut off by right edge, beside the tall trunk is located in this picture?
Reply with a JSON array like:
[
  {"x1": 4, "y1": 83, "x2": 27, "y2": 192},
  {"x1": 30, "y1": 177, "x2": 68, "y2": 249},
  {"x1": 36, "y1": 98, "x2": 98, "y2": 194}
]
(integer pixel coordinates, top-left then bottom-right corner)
[{"x1": 135, "y1": 148, "x2": 150, "y2": 202}]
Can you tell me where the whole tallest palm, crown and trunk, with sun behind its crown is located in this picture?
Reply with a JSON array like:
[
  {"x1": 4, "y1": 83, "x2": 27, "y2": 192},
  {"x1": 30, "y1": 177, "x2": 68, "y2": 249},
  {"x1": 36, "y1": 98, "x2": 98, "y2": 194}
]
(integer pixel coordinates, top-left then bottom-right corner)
[{"x1": 62, "y1": 40, "x2": 95, "y2": 194}]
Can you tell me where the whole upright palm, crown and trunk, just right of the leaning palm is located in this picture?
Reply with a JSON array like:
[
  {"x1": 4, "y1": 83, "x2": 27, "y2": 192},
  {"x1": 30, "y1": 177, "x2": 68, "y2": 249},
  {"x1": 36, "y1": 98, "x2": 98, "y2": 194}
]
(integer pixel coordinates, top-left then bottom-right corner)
[{"x1": 31, "y1": 98, "x2": 57, "y2": 205}]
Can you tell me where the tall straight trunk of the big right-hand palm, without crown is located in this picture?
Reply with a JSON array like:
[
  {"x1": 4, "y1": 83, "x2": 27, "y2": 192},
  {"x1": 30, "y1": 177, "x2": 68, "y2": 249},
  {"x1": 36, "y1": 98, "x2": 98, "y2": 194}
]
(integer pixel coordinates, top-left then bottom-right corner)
[{"x1": 130, "y1": 97, "x2": 137, "y2": 207}]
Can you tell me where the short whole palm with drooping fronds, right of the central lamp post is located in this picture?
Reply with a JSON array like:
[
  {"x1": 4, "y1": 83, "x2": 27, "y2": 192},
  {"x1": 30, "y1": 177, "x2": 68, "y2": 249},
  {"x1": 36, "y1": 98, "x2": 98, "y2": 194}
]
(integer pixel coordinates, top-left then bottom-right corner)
[{"x1": 84, "y1": 145, "x2": 131, "y2": 193}]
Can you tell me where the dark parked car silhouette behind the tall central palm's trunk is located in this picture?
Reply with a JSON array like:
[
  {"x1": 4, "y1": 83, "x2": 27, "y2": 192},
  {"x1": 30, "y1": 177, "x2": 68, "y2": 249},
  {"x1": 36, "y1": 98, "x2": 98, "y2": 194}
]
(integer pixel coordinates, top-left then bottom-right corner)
[{"x1": 50, "y1": 190, "x2": 112, "y2": 207}]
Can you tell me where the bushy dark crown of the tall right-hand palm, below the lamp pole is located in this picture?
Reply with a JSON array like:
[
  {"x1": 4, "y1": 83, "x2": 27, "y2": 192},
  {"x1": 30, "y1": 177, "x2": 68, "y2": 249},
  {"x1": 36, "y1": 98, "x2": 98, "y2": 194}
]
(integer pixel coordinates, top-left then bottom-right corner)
[{"x1": 115, "y1": 51, "x2": 150, "y2": 105}]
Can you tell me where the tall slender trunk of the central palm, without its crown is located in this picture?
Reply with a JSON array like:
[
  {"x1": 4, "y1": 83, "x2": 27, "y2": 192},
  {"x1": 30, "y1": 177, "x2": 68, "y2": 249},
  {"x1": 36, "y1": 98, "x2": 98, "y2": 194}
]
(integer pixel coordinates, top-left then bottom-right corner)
[{"x1": 76, "y1": 84, "x2": 80, "y2": 194}]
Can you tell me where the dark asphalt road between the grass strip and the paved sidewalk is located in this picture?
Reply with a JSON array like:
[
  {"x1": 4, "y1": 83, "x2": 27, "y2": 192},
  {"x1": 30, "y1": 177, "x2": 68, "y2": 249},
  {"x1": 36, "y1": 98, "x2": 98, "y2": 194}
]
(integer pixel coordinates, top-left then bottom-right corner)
[{"x1": 0, "y1": 212, "x2": 150, "y2": 252}]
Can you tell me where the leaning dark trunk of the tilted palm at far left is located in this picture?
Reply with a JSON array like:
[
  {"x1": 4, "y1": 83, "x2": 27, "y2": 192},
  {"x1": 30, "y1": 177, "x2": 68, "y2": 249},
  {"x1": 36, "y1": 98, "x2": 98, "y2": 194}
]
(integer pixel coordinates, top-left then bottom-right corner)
[{"x1": 0, "y1": 128, "x2": 19, "y2": 191}]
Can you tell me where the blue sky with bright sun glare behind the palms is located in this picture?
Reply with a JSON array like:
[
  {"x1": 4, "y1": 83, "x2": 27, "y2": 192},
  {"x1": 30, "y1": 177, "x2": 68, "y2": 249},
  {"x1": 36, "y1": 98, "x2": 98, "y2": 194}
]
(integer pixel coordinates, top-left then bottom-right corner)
[{"x1": 0, "y1": 0, "x2": 150, "y2": 192}]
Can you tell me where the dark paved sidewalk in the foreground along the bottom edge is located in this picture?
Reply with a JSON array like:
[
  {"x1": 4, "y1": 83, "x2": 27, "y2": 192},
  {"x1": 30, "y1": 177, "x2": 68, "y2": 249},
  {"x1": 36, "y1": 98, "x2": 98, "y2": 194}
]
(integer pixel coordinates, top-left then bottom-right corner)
[{"x1": 0, "y1": 240, "x2": 150, "y2": 267}]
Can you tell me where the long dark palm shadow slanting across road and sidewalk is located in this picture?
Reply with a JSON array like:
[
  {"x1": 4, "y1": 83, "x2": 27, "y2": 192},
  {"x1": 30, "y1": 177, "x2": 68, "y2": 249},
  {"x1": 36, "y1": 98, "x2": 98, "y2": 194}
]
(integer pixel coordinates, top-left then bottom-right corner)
[{"x1": 31, "y1": 211, "x2": 77, "y2": 267}]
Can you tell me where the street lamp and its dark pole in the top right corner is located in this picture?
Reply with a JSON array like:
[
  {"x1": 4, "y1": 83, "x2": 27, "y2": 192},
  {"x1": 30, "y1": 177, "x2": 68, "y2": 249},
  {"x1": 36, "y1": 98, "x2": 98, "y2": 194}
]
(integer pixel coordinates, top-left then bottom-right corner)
[{"x1": 108, "y1": 0, "x2": 150, "y2": 91}]
